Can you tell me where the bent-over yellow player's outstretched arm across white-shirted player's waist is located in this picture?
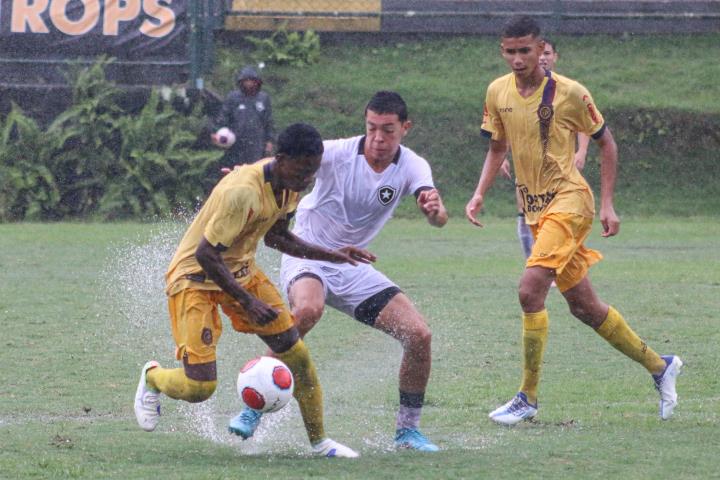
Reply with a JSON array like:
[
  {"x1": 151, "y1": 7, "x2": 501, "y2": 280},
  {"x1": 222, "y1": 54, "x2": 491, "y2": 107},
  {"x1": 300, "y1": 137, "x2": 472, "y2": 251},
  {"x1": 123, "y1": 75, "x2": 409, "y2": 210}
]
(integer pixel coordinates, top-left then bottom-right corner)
[{"x1": 265, "y1": 219, "x2": 376, "y2": 265}]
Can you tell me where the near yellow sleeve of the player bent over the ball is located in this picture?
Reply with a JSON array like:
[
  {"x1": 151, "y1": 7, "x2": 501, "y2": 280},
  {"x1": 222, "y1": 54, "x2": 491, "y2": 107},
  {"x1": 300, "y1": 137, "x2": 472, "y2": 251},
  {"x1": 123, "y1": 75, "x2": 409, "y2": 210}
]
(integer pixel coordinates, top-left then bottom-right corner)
[{"x1": 203, "y1": 187, "x2": 260, "y2": 248}]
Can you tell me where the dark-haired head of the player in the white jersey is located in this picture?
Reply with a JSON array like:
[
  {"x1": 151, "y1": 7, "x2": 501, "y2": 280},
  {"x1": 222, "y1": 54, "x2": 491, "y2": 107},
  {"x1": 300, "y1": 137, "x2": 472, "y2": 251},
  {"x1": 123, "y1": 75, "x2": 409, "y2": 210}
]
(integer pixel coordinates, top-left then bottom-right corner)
[{"x1": 365, "y1": 91, "x2": 412, "y2": 163}]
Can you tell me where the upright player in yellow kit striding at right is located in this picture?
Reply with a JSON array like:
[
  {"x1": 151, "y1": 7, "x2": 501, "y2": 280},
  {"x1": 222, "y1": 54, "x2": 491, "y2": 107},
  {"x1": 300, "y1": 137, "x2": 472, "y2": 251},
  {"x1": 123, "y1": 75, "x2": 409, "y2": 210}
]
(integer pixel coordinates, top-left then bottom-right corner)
[{"x1": 465, "y1": 16, "x2": 682, "y2": 425}]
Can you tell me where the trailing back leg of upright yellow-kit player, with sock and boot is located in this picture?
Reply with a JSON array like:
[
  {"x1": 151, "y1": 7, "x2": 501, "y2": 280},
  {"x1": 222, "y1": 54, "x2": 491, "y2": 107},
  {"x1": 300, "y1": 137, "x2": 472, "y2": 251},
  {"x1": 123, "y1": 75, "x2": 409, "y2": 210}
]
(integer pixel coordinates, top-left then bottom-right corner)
[{"x1": 563, "y1": 276, "x2": 682, "y2": 419}]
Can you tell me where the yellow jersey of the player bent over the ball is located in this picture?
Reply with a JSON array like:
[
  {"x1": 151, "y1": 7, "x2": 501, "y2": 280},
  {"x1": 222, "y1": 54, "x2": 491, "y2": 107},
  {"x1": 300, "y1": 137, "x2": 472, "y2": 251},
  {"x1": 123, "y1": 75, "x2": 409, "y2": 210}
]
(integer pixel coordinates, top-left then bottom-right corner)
[{"x1": 165, "y1": 158, "x2": 300, "y2": 296}]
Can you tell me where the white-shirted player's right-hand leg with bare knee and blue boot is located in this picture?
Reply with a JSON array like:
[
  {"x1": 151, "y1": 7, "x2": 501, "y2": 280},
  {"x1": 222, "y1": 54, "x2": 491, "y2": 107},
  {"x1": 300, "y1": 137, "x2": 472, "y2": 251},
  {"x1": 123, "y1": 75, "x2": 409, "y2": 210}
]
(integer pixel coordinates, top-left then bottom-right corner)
[{"x1": 372, "y1": 287, "x2": 439, "y2": 452}]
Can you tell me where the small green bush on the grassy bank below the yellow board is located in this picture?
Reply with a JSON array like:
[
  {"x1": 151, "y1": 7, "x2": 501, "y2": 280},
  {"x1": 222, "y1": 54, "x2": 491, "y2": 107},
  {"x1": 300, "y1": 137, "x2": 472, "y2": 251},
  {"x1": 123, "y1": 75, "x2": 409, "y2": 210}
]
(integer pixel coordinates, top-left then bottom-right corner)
[{"x1": 245, "y1": 22, "x2": 320, "y2": 67}]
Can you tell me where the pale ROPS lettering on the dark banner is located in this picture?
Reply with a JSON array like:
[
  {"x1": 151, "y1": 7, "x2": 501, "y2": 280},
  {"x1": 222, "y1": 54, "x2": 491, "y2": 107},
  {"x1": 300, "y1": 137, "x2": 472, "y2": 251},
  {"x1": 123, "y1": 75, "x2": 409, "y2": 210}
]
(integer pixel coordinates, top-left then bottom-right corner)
[{"x1": 10, "y1": 0, "x2": 175, "y2": 38}]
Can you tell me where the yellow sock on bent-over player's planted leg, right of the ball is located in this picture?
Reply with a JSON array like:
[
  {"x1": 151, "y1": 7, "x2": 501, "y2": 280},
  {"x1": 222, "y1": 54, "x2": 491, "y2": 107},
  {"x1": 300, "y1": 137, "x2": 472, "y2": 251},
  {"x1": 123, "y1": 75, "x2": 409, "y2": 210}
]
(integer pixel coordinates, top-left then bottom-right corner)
[{"x1": 277, "y1": 340, "x2": 325, "y2": 445}]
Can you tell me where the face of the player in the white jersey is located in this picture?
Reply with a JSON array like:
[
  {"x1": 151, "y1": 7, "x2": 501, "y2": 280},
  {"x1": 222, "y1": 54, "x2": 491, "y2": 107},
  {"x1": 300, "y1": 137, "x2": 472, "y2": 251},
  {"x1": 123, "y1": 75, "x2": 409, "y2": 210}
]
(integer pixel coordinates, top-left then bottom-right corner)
[{"x1": 365, "y1": 110, "x2": 410, "y2": 163}]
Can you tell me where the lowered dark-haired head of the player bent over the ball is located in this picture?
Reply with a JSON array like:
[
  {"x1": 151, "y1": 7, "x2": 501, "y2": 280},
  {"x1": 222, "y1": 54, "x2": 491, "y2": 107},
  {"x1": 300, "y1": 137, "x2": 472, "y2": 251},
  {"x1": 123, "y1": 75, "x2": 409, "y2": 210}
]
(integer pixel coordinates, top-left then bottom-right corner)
[{"x1": 274, "y1": 123, "x2": 324, "y2": 192}]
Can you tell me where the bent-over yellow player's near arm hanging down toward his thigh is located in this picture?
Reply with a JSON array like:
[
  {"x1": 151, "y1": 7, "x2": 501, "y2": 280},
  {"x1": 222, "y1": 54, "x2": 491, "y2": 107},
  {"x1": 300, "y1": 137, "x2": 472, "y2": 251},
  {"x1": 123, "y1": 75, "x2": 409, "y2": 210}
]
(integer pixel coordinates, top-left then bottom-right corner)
[{"x1": 195, "y1": 237, "x2": 278, "y2": 325}]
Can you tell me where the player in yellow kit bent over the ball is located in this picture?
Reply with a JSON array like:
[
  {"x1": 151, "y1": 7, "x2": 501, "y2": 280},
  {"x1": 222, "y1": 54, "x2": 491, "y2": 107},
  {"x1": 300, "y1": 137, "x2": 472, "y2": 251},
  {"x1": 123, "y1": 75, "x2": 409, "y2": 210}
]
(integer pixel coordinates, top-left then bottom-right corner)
[{"x1": 135, "y1": 124, "x2": 375, "y2": 457}]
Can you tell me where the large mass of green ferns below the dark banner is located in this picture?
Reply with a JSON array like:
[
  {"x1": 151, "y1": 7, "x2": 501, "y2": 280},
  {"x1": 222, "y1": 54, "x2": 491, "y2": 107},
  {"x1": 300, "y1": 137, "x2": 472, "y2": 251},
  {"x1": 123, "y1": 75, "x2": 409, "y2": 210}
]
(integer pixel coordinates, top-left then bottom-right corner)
[{"x1": 0, "y1": 58, "x2": 222, "y2": 221}]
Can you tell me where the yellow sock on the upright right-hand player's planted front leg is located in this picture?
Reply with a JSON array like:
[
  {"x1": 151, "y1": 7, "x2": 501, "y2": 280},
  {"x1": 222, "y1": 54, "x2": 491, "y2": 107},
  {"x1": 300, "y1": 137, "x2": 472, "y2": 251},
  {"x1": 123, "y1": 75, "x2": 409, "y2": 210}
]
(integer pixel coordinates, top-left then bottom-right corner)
[{"x1": 520, "y1": 310, "x2": 549, "y2": 404}]
